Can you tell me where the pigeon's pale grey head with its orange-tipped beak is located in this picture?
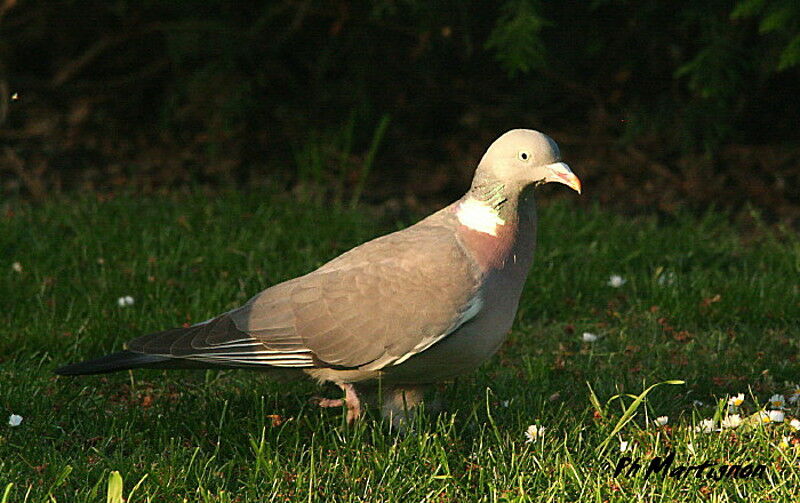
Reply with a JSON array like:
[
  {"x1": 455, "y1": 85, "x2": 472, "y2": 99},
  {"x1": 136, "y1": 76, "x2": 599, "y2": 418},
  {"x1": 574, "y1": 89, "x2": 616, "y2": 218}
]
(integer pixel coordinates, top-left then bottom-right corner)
[{"x1": 473, "y1": 129, "x2": 581, "y2": 193}]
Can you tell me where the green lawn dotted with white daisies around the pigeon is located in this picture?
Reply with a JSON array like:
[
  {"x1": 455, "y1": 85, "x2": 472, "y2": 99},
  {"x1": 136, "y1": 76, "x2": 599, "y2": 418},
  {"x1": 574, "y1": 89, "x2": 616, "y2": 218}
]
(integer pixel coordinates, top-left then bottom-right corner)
[{"x1": 0, "y1": 194, "x2": 800, "y2": 503}]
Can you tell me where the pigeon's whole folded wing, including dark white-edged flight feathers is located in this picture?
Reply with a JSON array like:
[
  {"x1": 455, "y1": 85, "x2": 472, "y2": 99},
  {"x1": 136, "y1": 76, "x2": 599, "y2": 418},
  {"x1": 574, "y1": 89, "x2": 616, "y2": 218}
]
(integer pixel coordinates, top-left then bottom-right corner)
[{"x1": 128, "y1": 213, "x2": 482, "y2": 370}]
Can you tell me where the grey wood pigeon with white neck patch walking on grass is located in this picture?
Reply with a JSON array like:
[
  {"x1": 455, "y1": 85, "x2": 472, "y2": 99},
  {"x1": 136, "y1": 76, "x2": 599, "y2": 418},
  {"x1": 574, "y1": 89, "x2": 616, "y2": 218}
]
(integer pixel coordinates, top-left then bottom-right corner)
[{"x1": 55, "y1": 129, "x2": 581, "y2": 422}]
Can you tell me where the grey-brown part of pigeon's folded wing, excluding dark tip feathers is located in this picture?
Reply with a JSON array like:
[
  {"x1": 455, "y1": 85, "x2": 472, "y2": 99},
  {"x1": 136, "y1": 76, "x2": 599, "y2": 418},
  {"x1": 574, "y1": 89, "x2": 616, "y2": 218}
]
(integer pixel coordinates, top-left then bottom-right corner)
[{"x1": 231, "y1": 220, "x2": 481, "y2": 369}]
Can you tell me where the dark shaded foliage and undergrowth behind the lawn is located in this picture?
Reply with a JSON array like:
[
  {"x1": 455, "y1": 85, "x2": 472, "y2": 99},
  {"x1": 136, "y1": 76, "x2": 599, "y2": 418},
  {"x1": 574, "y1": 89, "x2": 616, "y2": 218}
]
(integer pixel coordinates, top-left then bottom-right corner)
[{"x1": 0, "y1": 0, "x2": 800, "y2": 222}]
